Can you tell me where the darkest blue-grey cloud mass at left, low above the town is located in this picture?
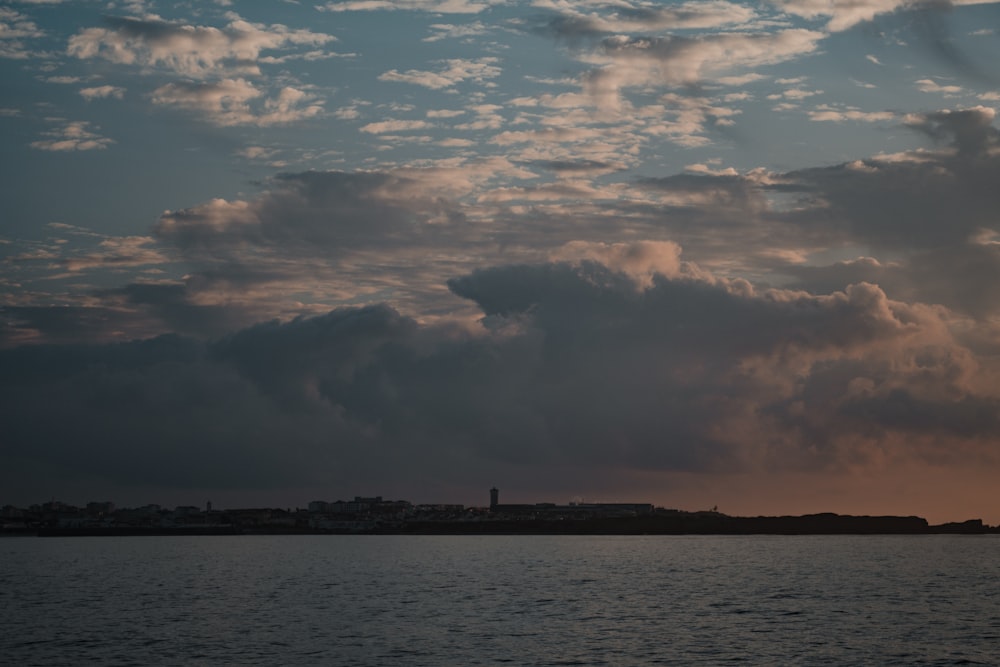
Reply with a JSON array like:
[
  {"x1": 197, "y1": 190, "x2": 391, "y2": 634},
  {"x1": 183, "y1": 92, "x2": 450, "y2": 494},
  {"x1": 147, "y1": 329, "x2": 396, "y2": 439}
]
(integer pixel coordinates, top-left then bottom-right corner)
[{"x1": 0, "y1": 309, "x2": 418, "y2": 498}]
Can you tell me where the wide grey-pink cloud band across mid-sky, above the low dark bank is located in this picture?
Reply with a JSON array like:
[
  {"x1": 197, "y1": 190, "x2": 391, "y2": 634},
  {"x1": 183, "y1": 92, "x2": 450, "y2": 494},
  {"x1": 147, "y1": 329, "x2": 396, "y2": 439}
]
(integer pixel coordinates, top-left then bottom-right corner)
[{"x1": 39, "y1": 98, "x2": 1000, "y2": 340}]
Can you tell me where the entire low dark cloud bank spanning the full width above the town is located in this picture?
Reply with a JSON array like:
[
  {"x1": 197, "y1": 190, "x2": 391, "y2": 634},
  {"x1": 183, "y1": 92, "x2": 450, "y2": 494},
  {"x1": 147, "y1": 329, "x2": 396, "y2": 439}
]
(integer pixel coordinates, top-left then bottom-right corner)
[{"x1": 0, "y1": 262, "x2": 997, "y2": 504}]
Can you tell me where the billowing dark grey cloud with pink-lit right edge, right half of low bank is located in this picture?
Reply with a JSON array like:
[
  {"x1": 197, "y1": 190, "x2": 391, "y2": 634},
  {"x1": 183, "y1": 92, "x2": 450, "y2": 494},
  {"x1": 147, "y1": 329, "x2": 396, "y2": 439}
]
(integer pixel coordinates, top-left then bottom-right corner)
[{"x1": 452, "y1": 264, "x2": 997, "y2": 465}]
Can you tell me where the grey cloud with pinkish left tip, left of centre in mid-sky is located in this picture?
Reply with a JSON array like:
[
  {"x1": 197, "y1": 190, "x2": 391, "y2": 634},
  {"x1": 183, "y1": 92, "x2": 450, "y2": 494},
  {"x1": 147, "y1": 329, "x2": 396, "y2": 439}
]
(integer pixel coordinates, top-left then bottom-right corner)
[{"x1": 154, "y1": 159, "x2": 533, "y2": 260}]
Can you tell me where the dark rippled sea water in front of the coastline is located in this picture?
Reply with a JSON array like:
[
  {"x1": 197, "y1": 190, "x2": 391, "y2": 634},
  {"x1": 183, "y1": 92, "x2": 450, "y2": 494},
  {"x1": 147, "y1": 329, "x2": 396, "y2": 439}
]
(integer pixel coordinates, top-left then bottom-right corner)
[{"x1": 0, "y1": 536, "x2": 1000, "y2": 666}]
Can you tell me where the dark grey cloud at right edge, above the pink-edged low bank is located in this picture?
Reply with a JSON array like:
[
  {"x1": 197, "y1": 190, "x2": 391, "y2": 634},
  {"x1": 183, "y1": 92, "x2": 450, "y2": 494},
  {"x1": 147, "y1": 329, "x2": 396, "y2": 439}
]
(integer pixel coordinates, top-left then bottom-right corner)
[{"x1": 761, "y1": 107, "x2": 1000, "y2": 320}]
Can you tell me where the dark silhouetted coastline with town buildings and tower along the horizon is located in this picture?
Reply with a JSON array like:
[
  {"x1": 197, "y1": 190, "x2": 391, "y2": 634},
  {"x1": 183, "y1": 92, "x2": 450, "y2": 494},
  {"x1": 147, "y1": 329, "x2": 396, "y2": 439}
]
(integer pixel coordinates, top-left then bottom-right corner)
[{"x1": 0, "y1": 489, "x2": 1000, "y2": 537}]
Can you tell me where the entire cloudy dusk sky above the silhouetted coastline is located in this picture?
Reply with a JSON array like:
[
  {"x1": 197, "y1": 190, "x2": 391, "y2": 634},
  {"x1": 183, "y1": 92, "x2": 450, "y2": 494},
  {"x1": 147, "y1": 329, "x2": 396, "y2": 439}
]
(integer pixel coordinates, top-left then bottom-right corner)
[{"x1": 0, "y1": 0, "x2": 1000, "y2": 524}]
